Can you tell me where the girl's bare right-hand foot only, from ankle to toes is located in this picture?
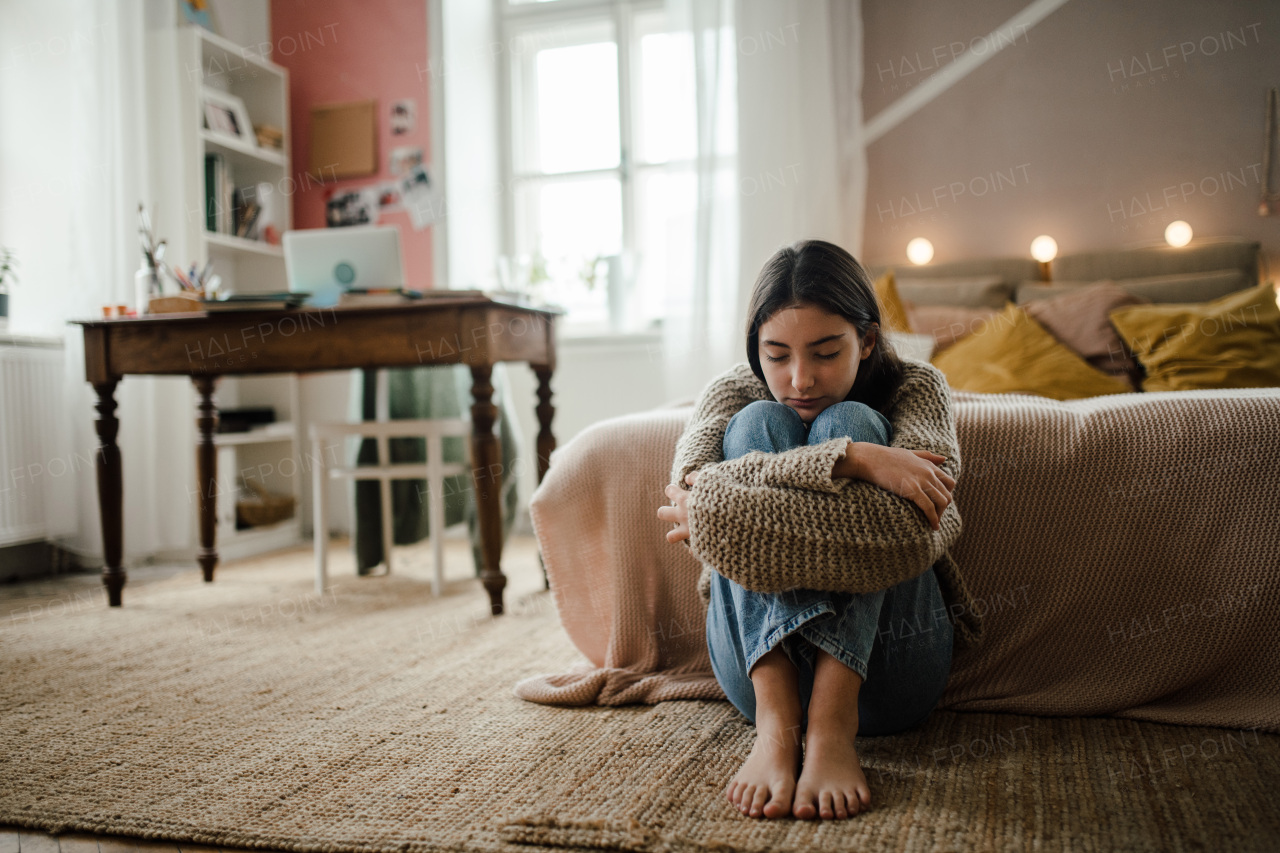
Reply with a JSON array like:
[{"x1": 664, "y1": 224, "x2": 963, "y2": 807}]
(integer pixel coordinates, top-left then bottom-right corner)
[{"x1": 792, "y1": 719, "x2": 872, "y2": 820}]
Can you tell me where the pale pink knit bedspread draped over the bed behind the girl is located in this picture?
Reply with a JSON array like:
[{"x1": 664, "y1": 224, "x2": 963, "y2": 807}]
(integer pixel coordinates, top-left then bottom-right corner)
[{"x1": 515, "y1": 388, "x2": 1280, "y2": 731}]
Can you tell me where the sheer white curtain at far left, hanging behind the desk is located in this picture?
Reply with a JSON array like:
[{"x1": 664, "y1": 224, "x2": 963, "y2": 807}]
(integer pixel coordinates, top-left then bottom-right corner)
[{"x1": 0, "y1": 0, "x2": 195, "y2": 565}]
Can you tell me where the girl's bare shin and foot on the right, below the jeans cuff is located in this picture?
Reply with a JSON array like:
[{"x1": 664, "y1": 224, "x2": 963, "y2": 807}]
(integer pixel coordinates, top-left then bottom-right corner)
[{"x1": 792, "y1": 649, "x2": 872, "y2": 820}]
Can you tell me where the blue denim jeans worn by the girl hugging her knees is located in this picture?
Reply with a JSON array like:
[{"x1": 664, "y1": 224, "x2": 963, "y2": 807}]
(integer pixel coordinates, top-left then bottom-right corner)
[{"x1": 707, "y1": 400, "x2": 952, "y2": 735}]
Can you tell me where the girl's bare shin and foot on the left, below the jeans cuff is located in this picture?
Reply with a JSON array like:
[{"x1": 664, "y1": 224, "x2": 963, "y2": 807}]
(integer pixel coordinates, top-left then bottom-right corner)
[{"x1": 724, "y1": 647, "x2": 801, "y2": 817}]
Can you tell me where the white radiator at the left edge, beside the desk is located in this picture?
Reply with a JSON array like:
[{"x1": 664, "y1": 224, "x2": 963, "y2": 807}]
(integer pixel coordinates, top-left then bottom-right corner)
[{"x1": 0, "y1": 336, "x2": 66, "y2": 547}]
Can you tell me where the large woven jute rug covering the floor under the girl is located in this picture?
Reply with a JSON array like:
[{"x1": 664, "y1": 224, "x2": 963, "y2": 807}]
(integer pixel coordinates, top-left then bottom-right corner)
[{"x1": 0, "y1": 540, "x2": 1280, "y2": 853}]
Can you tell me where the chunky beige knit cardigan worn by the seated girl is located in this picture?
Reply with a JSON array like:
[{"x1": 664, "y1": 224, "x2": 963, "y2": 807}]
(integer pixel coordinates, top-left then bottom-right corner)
[{"x1": 671, "y1": 359, "x2": 983, "y2": 647}]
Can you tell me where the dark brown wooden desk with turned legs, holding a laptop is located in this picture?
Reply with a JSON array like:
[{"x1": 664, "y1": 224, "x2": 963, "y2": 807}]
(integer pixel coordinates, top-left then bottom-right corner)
[{"x1": 74, "y1": 296, "x2": 561, "y2": 615}]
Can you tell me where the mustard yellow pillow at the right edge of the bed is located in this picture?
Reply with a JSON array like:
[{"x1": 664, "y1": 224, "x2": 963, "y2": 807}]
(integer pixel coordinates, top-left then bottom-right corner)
[{"x1": 1107, "y1": 284, "x2": 1280, "y2": 391}]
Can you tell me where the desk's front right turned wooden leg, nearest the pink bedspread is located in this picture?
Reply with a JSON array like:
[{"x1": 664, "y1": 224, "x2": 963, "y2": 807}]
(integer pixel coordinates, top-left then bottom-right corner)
[{"x1": 471, "y1": 365, "x2": 507, "y2": 616}]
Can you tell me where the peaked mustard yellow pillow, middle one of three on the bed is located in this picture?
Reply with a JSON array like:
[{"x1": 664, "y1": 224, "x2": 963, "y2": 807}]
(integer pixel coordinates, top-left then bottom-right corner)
[{"x1": 933, "y1": 302, "x2": 1133, "y2": 400}]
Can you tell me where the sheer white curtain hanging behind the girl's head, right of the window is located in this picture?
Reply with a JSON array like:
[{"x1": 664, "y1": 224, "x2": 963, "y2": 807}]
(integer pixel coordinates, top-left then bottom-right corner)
[{"x1": 663, "y1": 0, "x2": 867, "y2": 400}]
